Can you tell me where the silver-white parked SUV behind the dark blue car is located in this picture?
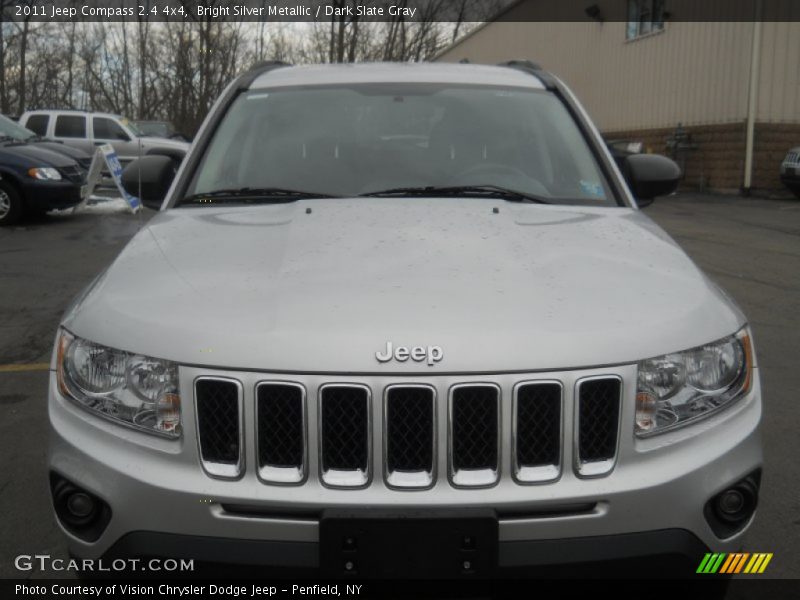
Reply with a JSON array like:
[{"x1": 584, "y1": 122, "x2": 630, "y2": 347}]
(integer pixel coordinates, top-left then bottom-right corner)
[{"x1": 20, "y1": 110, "x2": 189, "y2": 165}]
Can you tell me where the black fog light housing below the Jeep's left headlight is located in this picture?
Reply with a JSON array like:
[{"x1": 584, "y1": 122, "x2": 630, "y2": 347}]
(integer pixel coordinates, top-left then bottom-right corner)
[{"x1": 50, "y1": 473, "x2": 111, "y2": 542}]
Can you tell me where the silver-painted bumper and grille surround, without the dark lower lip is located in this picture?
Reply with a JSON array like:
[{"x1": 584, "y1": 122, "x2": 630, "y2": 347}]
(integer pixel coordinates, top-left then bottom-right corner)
[{"x1": 49, "y1": 365, "x2": 762, "y2": 560}]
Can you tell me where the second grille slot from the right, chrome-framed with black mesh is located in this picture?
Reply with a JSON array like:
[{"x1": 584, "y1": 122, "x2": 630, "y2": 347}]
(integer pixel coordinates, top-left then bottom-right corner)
[{"x1": 512, "y1": 381, "x2": 563, "y2": 483}]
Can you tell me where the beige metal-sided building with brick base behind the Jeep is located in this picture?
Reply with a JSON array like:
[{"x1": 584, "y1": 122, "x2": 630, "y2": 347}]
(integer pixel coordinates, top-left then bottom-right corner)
[{"x1": 437, "y1": 0, "x2": 800, "y2": 192}]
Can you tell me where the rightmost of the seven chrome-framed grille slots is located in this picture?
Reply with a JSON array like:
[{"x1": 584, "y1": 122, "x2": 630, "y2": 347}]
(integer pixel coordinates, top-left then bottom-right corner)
[{"x1": 575, "y1": 376, "x2": 622, "y2": 477}]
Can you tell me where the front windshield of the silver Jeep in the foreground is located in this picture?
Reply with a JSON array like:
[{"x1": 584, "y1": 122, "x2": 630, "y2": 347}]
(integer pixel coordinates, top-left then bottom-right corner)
[{"x1": 186, "y1": 83, "x2": 616, "y2": 206}]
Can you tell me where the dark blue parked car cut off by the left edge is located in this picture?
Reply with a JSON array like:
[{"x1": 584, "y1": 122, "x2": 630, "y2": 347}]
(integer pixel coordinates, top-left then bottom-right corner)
[{"x1": 0, "y1": 137, "x2": 86, "y2": 225}]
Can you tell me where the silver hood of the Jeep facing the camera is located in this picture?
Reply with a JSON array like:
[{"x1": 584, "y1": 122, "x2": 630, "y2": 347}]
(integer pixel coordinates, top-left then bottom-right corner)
[{"x1": 65, "y1": 198, "x2": 744, "y2": 374}]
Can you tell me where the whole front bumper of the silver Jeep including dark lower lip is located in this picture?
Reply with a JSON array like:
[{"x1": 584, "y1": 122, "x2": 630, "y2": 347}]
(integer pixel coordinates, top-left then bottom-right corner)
[{"x1": 49, "y1": 365, "x2": 762, "y2": 570}]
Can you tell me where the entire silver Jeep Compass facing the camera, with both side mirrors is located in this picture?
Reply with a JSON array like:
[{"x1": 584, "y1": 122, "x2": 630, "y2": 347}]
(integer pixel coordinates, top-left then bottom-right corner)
[{"x1": 49, "y1": 62, "x2": 762, "y2": 576}]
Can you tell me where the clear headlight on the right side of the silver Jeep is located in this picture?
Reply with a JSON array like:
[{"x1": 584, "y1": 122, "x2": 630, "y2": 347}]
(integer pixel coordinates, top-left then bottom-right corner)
[{"x1": 636, "y1": 328, "x2": 753, "y2": 437}]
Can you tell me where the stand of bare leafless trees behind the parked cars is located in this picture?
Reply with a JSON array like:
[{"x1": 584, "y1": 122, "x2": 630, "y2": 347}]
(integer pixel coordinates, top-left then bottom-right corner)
[{"x1": 0, "y1": 0, "x2": 501, "y2": 133}]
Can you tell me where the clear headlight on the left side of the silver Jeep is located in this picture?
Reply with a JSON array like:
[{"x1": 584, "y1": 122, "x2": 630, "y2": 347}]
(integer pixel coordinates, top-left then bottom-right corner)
[{"x1": 57, "y1": 330, "x2": 181, "y2": 438}]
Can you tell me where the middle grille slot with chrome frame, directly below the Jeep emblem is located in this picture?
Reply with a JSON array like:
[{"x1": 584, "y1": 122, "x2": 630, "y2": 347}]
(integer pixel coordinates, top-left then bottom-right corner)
[{"x1": 384, "y1": 385, "x2": 436, "y2": 488}]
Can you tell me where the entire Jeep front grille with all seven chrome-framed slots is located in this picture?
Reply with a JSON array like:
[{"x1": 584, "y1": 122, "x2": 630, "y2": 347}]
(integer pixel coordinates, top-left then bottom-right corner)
[{"x1": 189, "y1": 367, "x2": 624, "y2": 490}]
